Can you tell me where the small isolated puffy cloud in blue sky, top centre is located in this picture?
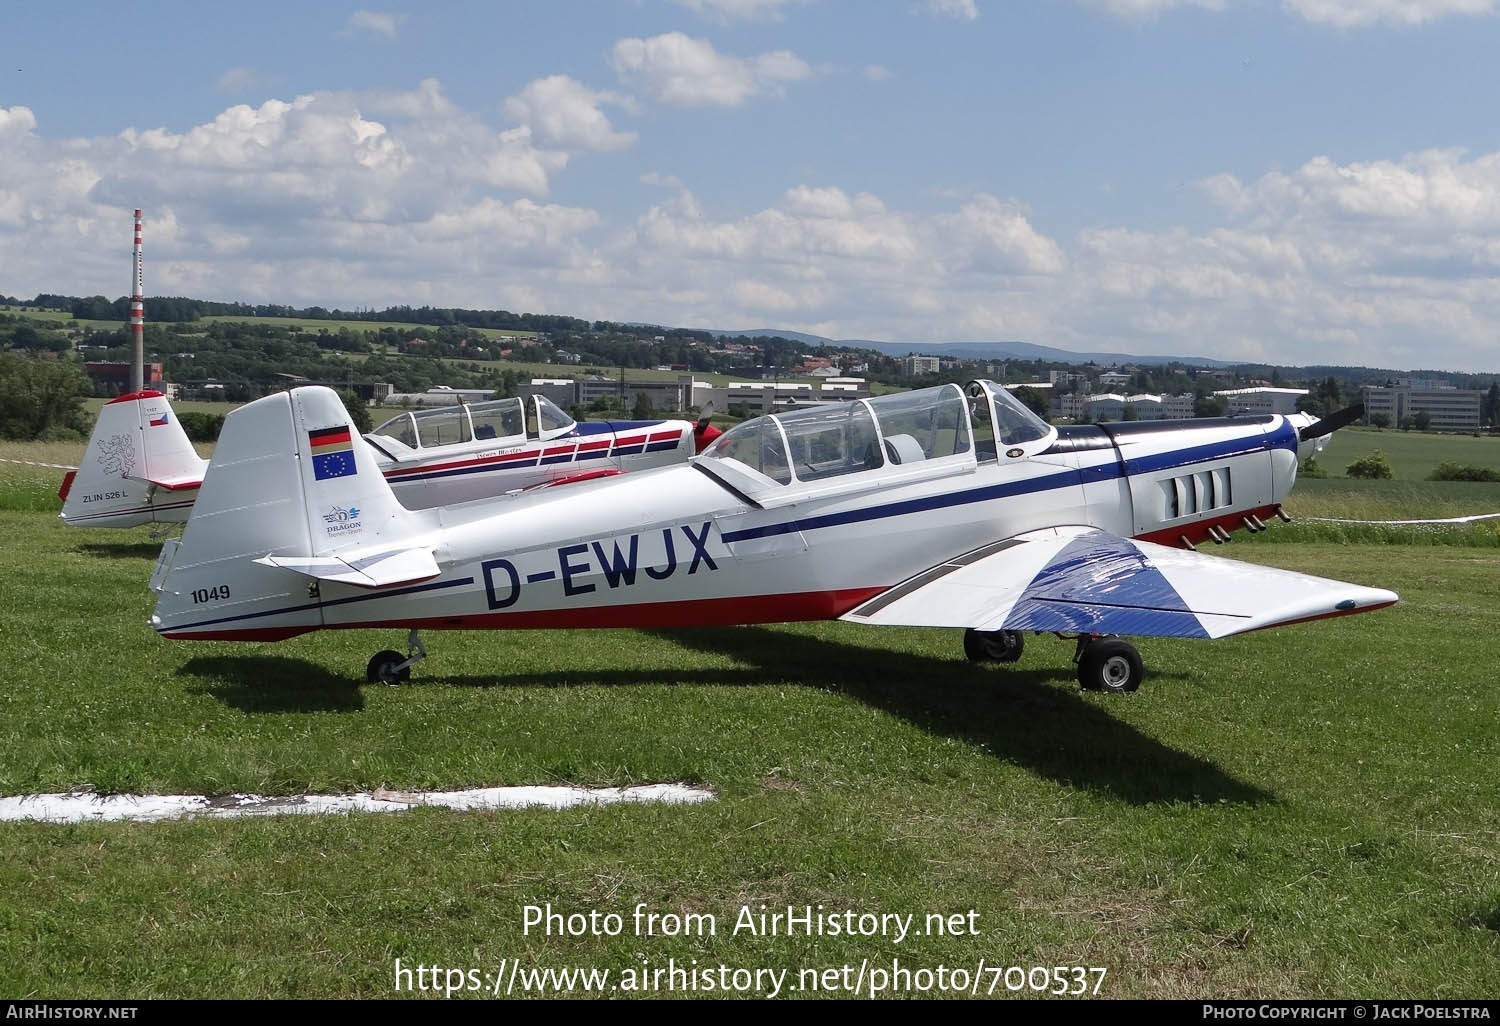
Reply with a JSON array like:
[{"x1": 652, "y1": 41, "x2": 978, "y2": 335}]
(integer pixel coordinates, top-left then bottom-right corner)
[{"x1": 609, "y1": 32, "x2": 812, "y2": 107}]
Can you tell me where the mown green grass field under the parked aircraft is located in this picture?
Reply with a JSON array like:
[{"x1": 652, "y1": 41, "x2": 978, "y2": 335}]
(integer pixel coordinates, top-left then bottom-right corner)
[{"x1": 0, "y1": 435, "x2": 1500, "y2": 999}]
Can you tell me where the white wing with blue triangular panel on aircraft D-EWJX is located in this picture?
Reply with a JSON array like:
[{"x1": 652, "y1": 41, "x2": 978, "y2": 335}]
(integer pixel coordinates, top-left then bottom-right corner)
[{"x1": 842, "y1": 527, "x2": 1397, "y2": 638}]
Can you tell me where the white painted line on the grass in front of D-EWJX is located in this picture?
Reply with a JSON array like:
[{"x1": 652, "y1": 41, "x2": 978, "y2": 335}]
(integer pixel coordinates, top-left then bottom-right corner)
[{"x1": 0, "y1": 783, "x2": 717, "y2": 824}]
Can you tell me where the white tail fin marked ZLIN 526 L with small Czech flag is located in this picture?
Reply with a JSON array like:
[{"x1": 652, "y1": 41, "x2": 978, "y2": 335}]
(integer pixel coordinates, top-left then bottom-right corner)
[{"x1": 62, "y1": 392, "x2": 209, "y2": 528}]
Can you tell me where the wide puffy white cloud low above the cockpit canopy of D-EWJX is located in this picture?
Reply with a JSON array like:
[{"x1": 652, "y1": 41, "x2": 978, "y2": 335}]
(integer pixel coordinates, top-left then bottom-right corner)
[{"x1": 602, "y1": 185, "x2": 1065, "y2": 339}]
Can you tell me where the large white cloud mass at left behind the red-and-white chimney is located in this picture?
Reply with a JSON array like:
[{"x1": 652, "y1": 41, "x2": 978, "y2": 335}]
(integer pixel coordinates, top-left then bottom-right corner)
[{"x1": 0, "y1": 88, "x2": 599, "y2": 306}]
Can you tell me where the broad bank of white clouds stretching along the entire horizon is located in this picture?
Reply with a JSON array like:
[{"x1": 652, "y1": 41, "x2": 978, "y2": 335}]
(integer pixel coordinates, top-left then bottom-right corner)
[{"x1": 0, "y1": 80, "x2": 1500, "y2": 369}]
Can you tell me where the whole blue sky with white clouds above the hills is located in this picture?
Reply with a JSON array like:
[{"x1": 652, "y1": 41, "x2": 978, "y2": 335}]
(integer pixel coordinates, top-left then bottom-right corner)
[{"x1": 0, "y1": 0, "x2": 1500, "y2": 374}]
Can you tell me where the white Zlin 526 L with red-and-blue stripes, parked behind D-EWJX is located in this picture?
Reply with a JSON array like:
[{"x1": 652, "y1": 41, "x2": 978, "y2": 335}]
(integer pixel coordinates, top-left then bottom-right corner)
[{"x1": 59, "y1": 390, "x2": 714, "y2": 528}]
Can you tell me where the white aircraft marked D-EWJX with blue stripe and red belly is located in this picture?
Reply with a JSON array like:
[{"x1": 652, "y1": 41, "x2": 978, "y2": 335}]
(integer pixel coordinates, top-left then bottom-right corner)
[{"x1": 152, "y1": 381, "x2": 1397, "y2": 692}]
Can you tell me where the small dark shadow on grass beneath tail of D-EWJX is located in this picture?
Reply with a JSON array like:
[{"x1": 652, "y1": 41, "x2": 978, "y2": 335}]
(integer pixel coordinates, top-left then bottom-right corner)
[{"x1": 177, "y1": 656, "x2": 365, "y2": 713}]
